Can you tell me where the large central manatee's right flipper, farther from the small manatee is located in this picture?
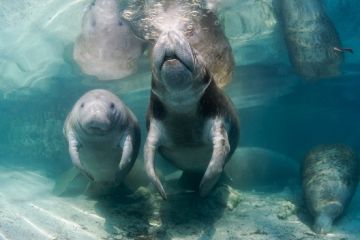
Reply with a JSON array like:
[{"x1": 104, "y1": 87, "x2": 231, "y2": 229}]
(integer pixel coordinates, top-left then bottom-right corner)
[{"x1": 199, "y1": 118, "x2": 230, "y2": 197}]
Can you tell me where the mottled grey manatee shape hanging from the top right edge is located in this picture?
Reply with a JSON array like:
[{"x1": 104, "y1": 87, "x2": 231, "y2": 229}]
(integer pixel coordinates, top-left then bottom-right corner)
[{"x1": 279, "y1": 0, "x2": 343, "y2": 79}]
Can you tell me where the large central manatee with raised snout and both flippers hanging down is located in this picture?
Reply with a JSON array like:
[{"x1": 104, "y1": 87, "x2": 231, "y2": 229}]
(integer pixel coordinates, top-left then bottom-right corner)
[{"x1": 144, "y1": 31, "x2": 239, "y2": 199}]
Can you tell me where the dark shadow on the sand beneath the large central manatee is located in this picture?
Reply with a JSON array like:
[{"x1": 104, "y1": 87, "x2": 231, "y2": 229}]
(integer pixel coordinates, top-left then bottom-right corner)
[{"x1": 91, "y1": 179, "x2": 228, "y2": 240}]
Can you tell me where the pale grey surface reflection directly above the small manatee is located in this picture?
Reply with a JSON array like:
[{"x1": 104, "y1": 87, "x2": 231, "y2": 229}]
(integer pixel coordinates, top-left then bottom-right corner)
[{"x1": 73, "y1": 0, "x2": 144, "y2": 80}]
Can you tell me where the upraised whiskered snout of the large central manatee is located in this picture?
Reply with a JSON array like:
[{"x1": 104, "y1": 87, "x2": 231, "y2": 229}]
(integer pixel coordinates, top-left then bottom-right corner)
[{"x1": 152, "y1": 31, "x2": 196, "y2": 89}]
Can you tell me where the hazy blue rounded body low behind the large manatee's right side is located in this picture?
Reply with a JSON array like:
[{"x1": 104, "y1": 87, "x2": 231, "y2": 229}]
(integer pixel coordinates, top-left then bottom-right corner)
[{"x1": 224, "y1": 147, "x2": 299, "y2": 190}]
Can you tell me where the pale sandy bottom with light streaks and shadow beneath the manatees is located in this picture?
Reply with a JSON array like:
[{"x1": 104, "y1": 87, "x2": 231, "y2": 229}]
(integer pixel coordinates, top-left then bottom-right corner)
[{"x1": 0, "y1": 167, "x2": 360, "y2": 240}]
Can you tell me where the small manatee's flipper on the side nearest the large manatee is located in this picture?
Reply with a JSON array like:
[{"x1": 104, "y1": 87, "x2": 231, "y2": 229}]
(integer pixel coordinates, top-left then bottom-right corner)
[{"x1": 116, "y1": 130, "x2": 140, "y2": 183}]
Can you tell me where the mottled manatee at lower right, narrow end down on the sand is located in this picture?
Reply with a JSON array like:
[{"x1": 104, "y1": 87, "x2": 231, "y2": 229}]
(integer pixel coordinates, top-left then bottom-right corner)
[{"x1": 302, "y1": 144, "x2": 359, "y2": 233}]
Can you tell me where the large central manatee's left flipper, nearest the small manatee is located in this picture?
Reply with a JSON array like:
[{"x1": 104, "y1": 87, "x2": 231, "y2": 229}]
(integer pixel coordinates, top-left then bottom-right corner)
[{"x1": 144, "y1": 121, "x2": 167, "y2": 199}]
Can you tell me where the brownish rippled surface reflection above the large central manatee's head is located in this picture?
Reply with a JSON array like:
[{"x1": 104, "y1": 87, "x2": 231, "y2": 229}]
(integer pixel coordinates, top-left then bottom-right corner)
[{"x1": 123, "y1": 0, "x2": 235, "y2": 87}]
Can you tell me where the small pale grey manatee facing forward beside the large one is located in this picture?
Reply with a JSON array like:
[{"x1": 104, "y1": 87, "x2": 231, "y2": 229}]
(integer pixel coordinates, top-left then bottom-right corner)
[{"x1": 64, "y1": 89, "x2": 140, "y2": 185}]
